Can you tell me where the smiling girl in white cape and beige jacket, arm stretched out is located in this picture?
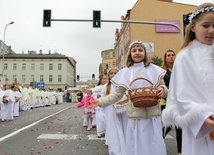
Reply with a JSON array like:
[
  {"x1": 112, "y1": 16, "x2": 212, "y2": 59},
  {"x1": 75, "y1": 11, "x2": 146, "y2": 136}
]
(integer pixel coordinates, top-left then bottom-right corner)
[{"x1": 90, "y1": 40, "x2": 167, "y2": 155}]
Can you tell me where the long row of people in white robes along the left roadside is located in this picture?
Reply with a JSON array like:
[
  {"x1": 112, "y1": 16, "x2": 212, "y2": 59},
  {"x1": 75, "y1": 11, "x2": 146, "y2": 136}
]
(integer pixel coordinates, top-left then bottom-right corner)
[{"x1": 0, "y1": 81, "x2": 65, "y2": 122}]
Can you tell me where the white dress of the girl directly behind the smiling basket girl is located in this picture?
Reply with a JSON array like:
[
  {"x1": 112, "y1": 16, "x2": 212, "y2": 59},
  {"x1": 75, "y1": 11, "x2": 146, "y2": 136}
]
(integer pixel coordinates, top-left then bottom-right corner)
[{"x1": 101, "y1": 84, "x2": 128, "y2": 155}]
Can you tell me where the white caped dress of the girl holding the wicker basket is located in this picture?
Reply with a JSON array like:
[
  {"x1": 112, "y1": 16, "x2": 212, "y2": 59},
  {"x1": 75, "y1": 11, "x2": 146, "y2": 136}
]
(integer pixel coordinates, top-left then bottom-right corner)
[{"x1": 98, "y1": 62, "x2": 166, "y2": 155}]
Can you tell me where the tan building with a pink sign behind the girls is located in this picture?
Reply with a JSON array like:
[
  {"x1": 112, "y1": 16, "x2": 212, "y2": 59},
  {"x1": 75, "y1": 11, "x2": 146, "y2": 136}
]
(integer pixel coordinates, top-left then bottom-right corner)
[{"x1": 115, "y1": 0, "x2": 196, "y2": 69}]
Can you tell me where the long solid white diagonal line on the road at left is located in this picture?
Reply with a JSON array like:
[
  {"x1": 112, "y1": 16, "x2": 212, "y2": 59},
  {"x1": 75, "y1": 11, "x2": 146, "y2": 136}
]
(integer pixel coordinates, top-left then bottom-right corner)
[{"x1": 0, "y1": 108, "x2": 69, "y2": 142}]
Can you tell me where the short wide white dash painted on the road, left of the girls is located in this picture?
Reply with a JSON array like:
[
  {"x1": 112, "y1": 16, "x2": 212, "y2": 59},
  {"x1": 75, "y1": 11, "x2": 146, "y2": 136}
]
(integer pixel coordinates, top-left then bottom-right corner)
[{"x1": 37, "y1": 134, "x2": 79, "y2": 140}]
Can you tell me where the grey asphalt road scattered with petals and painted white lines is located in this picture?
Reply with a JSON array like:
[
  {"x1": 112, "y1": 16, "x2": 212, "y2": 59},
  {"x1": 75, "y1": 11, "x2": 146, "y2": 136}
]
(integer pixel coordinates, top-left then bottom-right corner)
[{"x1": 0, "y1": 103, "x2": 176, "y2": 155}]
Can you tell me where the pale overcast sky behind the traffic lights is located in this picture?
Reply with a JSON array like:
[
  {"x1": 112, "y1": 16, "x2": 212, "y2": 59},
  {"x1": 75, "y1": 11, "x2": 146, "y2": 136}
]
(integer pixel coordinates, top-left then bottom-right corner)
[{"x1": 0, "y1": 0, "x2": 213, "y2": 80}]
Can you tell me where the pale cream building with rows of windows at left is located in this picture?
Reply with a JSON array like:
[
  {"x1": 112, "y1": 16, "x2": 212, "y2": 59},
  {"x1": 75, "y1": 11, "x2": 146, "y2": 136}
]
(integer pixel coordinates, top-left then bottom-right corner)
[{"x1": 0, "y1": 51, "x2": 76, "y2": 90}]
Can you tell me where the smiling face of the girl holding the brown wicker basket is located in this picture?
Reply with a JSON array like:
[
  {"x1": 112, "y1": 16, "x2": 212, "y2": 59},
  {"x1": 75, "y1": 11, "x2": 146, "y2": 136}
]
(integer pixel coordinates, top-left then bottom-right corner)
[{"x1": 131, "y1": 44, "x2": 146, "y2": 63}]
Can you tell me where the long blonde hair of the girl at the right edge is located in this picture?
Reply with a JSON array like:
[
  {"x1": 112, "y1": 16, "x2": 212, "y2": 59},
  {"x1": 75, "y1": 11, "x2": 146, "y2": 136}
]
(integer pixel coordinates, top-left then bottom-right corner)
[{"x1": 181, "y1": 3, "x2": 214, "y2": 49}]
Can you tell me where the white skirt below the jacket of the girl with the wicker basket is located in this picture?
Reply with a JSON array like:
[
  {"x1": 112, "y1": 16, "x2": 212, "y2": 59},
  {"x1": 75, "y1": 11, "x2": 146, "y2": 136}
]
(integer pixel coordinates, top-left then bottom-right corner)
[{"x1": 125, "y1": 116, "x2": 166, "y2": 155}]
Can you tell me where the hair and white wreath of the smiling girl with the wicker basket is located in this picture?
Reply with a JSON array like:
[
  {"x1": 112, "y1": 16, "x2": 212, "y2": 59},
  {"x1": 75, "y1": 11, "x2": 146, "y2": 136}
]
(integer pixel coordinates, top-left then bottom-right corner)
[{"x1": 126, "y1": 40, "x2": 150, "y2": 67}]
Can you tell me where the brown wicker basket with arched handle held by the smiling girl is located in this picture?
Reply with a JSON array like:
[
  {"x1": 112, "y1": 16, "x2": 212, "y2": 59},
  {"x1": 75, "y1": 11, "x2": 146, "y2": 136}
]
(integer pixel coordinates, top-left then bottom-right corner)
[{"x1": 129, "y1": 78, "x2": 158, "y2": 108}]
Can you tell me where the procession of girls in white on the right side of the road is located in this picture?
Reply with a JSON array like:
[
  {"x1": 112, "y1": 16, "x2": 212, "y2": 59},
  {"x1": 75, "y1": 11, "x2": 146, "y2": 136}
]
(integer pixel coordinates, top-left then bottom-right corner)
[{"x1": 77, "y1": 3, "x2": 214, "y2": 155}]
